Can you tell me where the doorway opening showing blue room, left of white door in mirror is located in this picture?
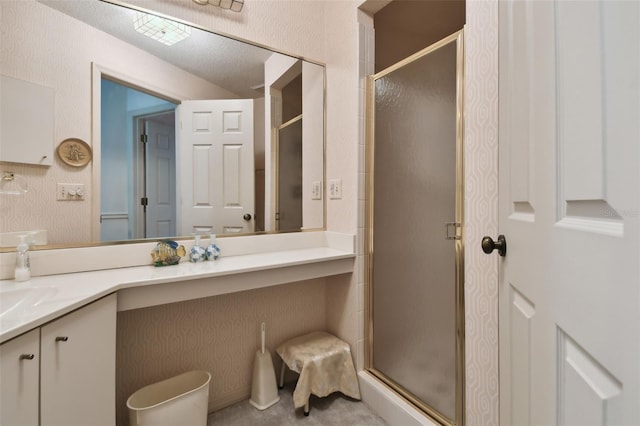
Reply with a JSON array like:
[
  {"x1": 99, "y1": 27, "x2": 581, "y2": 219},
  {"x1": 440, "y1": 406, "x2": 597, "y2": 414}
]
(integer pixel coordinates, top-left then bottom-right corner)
[{"x1": 100, "y1": 78, "x2": 176, "y2": 241}]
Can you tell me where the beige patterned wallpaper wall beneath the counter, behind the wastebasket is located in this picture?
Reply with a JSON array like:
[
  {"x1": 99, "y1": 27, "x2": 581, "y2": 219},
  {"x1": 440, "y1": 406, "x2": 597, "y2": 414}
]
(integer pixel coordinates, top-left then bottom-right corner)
[{"x1": 116, "y1": 279, "x2": 326, "y2": 426}]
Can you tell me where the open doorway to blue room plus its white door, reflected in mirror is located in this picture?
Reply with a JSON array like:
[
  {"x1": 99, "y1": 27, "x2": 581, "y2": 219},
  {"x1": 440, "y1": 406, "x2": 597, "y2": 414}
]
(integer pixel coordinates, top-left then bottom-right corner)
[{"x1": 100, "y1": 78, "x2": 254, "y2": 241}]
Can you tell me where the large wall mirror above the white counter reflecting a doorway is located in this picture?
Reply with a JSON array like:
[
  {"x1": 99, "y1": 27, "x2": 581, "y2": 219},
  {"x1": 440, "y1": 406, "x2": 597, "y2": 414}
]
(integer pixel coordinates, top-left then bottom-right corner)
[{"x1": 0, "y1": 0, "x2": 325, "y2": 251}]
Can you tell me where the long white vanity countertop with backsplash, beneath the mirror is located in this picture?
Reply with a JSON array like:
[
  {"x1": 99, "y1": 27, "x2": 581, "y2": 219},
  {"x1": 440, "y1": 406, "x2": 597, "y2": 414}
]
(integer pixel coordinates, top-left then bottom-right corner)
[{"x1": 0, "y1": 232, "x2": 355, "y2": 343}]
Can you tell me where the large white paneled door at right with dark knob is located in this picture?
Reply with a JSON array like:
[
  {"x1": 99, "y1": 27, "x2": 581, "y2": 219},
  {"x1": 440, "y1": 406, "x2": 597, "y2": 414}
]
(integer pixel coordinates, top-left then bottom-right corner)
[{"x1": 494, "y1": 0, "x2": 640, "y2": 426}]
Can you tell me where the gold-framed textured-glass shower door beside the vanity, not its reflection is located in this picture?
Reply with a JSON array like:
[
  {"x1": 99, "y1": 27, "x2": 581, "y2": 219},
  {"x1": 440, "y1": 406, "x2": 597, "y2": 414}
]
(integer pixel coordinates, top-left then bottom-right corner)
[{"x1": 366, "y1": 31, "x2": 464, "y2": 425}]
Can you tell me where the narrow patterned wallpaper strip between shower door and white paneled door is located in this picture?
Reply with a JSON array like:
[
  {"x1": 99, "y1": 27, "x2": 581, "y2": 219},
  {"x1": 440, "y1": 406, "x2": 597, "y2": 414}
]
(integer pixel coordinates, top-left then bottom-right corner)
[{"x1": 464, "y1": 0, "x2": 499, "y2": 426}]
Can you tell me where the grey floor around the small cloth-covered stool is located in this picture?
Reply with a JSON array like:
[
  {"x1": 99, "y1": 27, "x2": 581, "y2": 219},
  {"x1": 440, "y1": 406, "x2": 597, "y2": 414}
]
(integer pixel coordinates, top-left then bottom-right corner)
[{"x1": 208, "y1": 384, "x2": 387, "y2": 426}]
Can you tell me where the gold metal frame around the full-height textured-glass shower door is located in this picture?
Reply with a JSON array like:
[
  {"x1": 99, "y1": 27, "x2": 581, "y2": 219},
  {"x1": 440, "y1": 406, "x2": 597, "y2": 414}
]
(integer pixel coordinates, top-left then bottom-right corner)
[{"x1": 364, "y1": 30, "x2": 465, "y2": 426}]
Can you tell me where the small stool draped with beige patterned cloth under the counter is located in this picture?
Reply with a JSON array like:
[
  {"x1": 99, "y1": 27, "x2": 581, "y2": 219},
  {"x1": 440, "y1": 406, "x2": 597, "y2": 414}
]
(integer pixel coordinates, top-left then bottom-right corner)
[{"x1": 276, "y1": 331, "x2": 360, "y2": 416}]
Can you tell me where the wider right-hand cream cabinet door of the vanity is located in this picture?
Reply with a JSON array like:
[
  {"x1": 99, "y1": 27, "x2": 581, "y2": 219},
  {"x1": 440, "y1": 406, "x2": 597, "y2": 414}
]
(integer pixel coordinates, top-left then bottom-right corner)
[{"x1": 40, "y1": 294, "x2": 116, "y2": 426}]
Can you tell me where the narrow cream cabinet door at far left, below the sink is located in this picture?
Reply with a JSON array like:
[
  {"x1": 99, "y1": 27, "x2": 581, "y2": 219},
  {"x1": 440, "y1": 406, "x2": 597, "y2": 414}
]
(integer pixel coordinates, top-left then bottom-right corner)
[{"x1": 0, "y1": 329, "x2": 40, "y2": 426}]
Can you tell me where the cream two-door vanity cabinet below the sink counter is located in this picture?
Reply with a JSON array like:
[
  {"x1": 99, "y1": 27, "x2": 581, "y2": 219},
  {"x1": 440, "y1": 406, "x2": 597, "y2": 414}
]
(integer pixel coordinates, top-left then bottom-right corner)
[{"x1": 0, "y1": 294, "x2": 117, "y2": 426}]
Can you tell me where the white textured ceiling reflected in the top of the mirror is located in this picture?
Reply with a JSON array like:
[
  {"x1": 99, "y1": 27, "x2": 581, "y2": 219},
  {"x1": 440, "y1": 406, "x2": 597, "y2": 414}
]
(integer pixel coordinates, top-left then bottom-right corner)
[{"x1": 38, "y1": 0, "x2": 282, "y2": 98}]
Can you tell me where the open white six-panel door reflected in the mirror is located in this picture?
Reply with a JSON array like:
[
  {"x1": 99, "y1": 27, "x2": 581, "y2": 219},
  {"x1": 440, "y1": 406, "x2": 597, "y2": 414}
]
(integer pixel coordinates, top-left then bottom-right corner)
[{"x1": 177, "y1": 99, "x2": 254, "y2": 235}]
